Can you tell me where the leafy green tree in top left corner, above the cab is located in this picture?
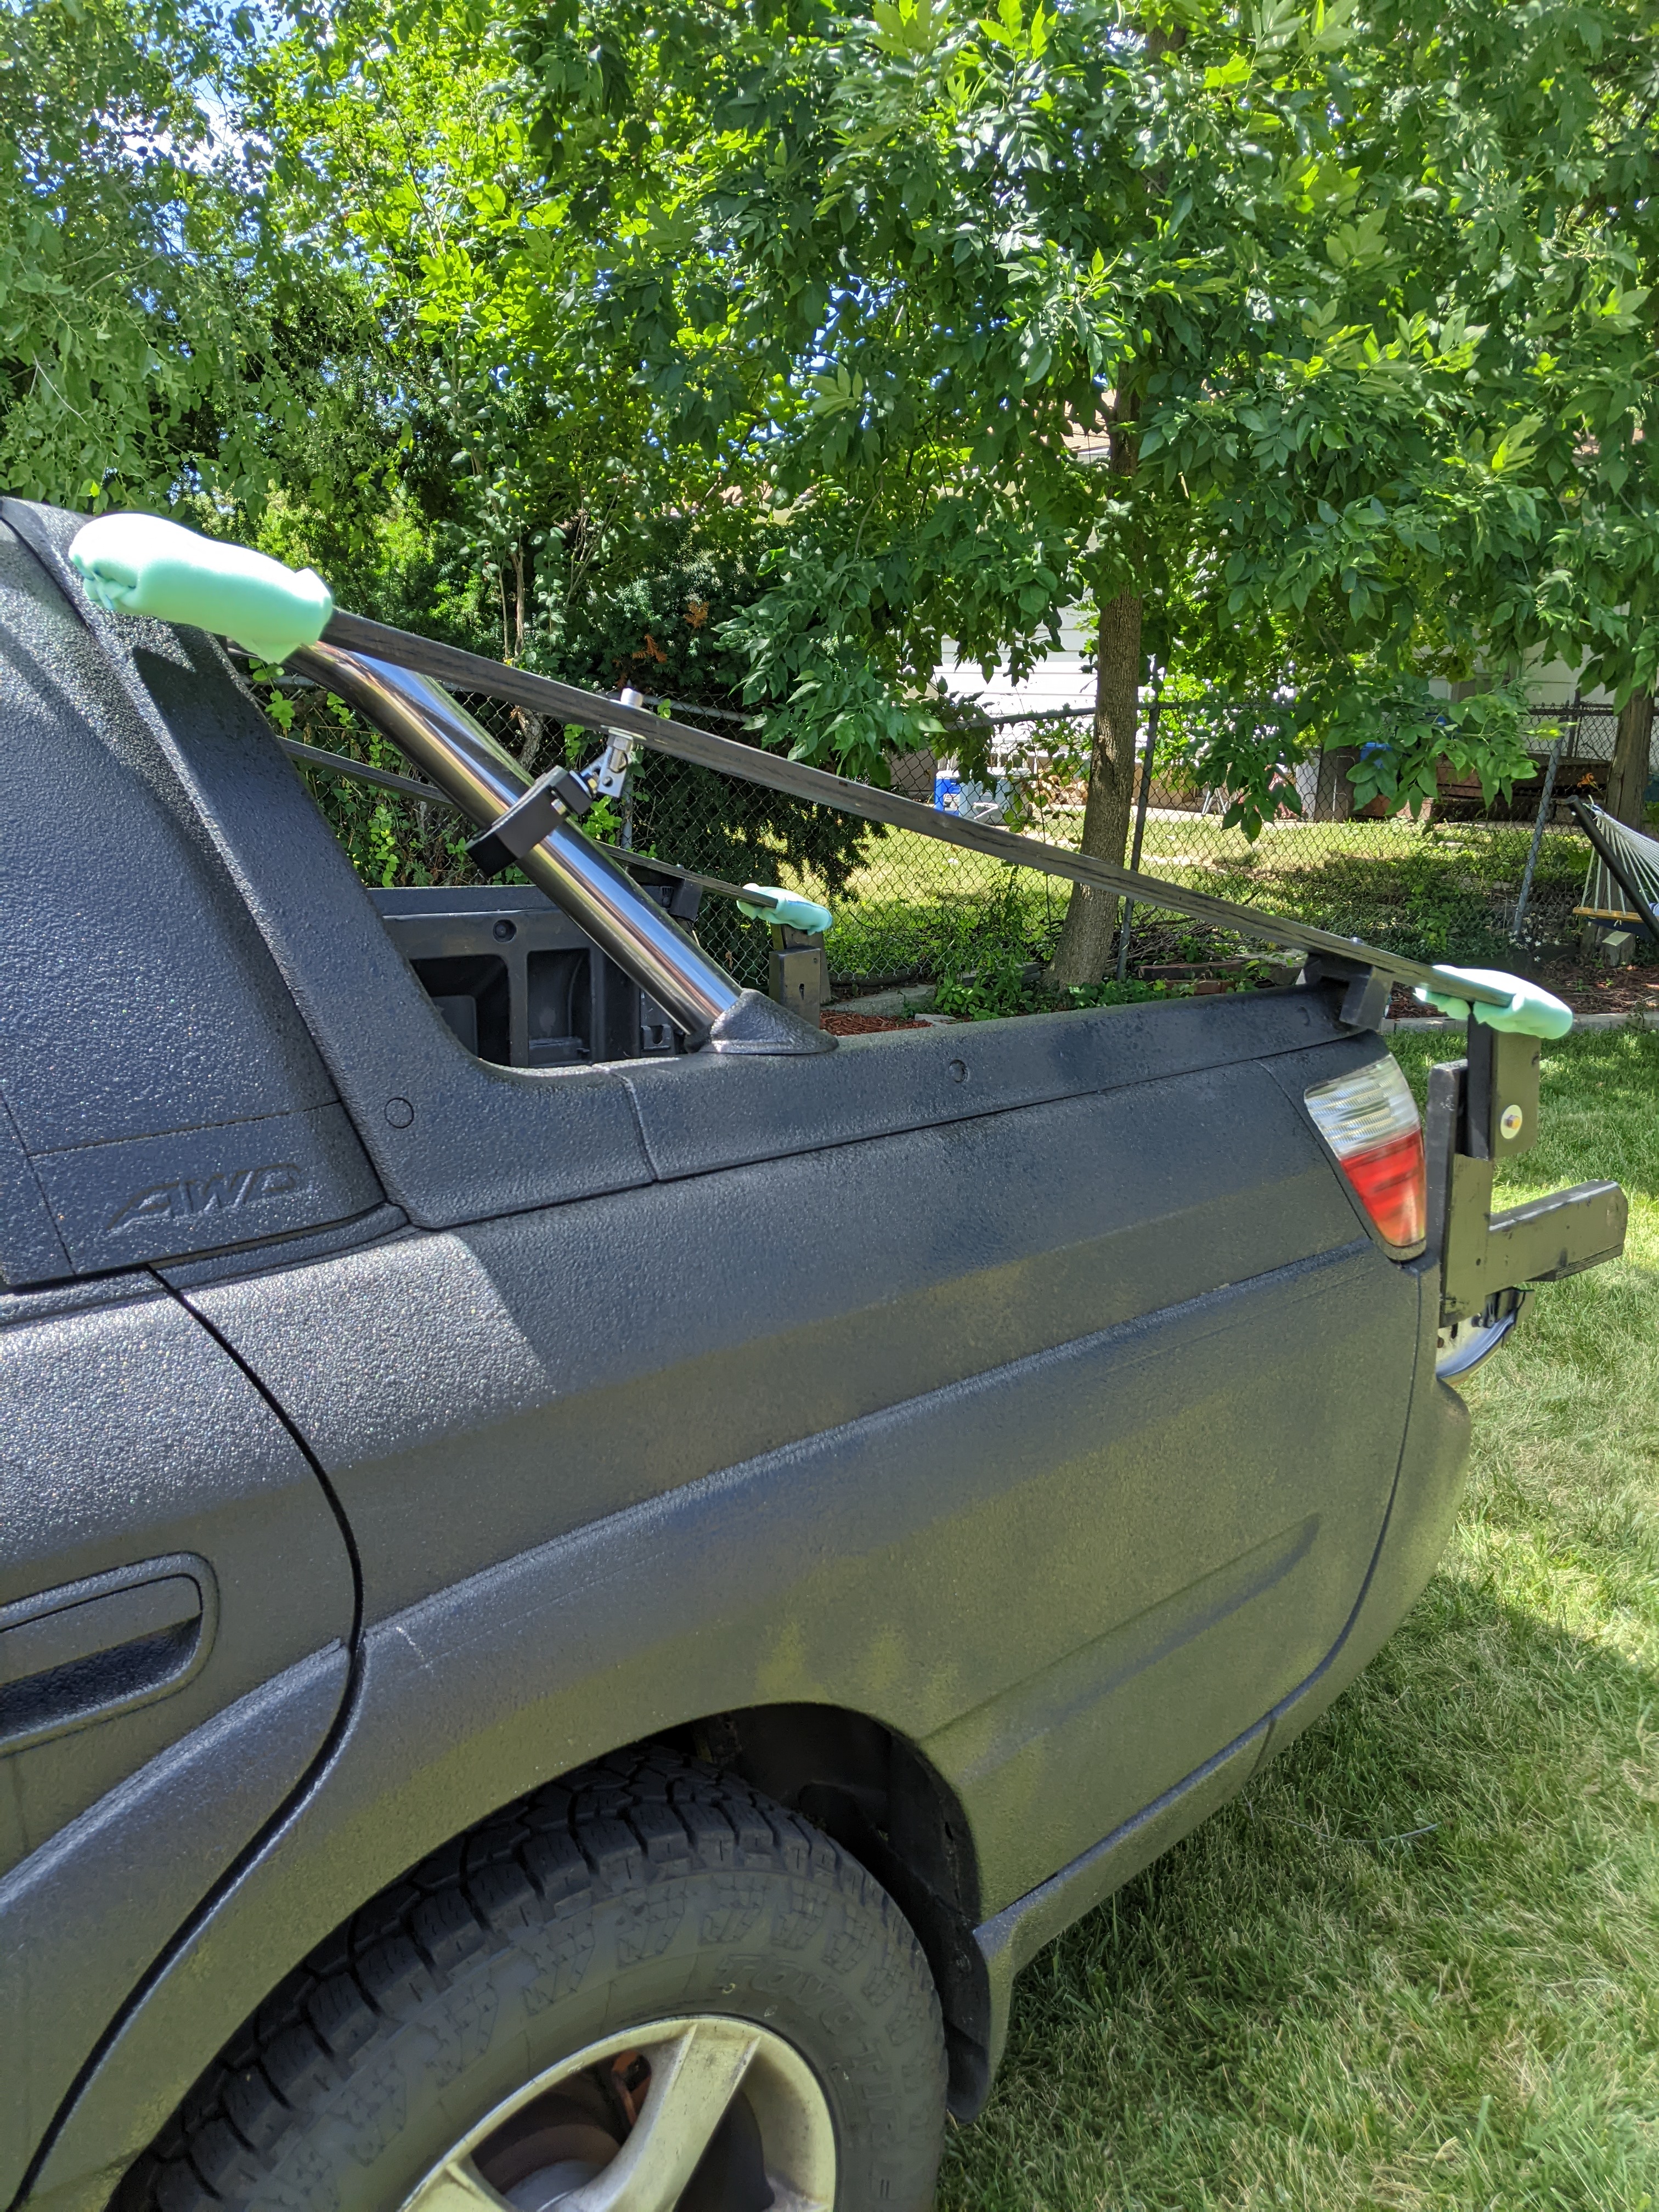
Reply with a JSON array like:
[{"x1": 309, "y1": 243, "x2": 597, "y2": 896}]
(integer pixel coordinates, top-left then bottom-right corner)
[{"x1": 0, "y1": 0, "x2": 367, "y2": 527}]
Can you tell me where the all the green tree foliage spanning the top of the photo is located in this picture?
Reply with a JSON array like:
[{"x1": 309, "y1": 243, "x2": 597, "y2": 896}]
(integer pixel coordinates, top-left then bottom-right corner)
[{"x1": 16, "y1": 0, "x2": 1659, "y2": 832}]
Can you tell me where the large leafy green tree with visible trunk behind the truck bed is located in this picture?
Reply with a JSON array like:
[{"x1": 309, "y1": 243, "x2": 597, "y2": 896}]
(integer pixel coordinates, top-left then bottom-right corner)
[{"x1": 520, "y1": 0, "x2": 1659, "y2": 982}]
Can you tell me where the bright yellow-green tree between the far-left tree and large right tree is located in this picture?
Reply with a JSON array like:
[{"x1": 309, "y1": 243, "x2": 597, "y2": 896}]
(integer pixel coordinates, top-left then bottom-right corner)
[{"x1": 248, "y1": 7, "x2": 637, "y2": 659}]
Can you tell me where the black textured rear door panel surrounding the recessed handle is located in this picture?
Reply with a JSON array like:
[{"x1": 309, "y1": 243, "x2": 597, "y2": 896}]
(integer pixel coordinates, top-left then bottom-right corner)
[{"x1": 0, "y1": 1276, "x2": 356, "y2": 2194}]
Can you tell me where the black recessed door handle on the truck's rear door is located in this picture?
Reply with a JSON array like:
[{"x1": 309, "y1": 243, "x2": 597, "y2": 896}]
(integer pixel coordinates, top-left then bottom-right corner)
[{"x1": 0, "y1": 1553, "x2": 219, "y2": 1752}]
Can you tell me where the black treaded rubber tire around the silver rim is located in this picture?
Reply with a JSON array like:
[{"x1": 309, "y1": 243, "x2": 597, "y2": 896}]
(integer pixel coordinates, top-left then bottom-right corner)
[{"x1": 120, "y1": 1750, "x2": 945, "y2": 2212}]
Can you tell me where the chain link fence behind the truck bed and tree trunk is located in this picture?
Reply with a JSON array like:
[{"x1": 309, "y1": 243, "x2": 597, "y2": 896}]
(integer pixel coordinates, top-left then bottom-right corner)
[{"x1": 268, "y1": 684, "x2": 1645, "y2": 993}]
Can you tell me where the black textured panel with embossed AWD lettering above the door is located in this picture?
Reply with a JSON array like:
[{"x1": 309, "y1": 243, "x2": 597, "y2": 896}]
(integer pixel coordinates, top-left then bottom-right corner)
[{"x1": 0, "y1": 531, "x2": 381, "y2": 1288}]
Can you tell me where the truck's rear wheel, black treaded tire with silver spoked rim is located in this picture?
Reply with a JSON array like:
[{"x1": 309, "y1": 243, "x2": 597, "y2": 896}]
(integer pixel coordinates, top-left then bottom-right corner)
[{"x1": 124, "y1": 1752, "x2": 945, "y2": 2212}]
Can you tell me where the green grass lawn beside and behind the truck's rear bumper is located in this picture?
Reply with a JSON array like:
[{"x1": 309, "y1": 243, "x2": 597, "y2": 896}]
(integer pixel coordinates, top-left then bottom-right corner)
[{"x1": 940, "y1": 1033, "x2": 1659, "y2": 2212}]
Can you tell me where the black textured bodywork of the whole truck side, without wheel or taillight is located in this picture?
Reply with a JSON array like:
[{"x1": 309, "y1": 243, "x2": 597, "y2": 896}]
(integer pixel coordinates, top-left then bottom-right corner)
[{"x1": 0, "y1": 511, "x2": 1464, "y2": 2212}]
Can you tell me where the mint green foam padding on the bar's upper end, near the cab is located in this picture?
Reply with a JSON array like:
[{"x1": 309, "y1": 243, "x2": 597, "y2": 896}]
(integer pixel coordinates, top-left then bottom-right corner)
[{"x1": 69, "y1": 515, "x2": 334, "y2": 662}]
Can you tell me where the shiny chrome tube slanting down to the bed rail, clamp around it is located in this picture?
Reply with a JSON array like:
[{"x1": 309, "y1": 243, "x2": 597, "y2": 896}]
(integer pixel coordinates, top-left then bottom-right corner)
[{"x1": 287, "y1": 646, "x2": 743, "y2": 1044}]
